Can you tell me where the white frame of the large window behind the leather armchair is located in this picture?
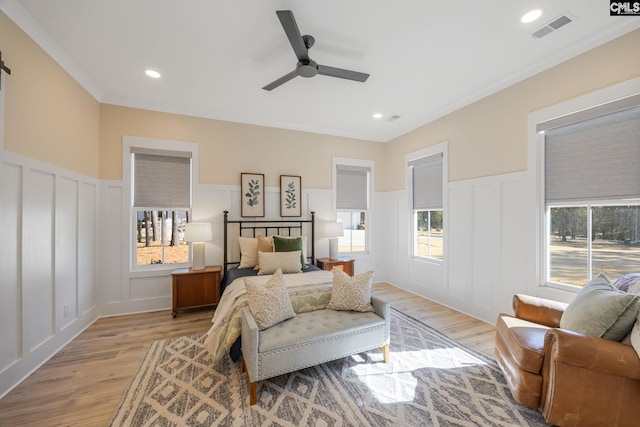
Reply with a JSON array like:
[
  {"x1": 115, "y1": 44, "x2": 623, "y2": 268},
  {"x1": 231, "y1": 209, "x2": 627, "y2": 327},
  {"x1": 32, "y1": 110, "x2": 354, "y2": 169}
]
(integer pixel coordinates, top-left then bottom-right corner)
[{"x1": 527, "y1": 77, "x2": 640, "y2": 297}]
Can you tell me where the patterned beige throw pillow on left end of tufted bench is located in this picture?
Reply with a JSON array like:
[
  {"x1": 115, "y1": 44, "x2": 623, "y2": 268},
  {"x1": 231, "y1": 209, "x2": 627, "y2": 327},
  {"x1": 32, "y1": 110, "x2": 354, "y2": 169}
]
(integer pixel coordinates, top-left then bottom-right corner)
[{"x1": 244, "y1": 270, "x2": 296, "y2": 331}]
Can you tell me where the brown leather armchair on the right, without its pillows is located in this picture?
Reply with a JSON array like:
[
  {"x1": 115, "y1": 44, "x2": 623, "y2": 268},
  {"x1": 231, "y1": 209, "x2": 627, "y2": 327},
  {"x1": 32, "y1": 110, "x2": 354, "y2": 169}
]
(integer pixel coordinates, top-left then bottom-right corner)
[{"x1": 495, "y1": 295, "x2": 640, "y2": 427}]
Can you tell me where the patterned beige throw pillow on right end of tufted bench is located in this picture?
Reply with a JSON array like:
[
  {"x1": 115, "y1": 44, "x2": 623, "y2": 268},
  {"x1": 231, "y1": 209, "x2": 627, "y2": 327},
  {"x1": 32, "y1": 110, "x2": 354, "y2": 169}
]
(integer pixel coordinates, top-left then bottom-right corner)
[{"x1": 327, "y1": 268, "x2": 373, "y2": 311}]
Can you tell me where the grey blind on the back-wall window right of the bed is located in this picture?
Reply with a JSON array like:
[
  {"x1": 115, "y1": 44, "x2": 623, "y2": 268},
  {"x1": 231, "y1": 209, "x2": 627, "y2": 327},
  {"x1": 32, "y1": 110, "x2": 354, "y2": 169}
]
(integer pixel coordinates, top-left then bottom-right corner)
[{"x1": 336, "y1": 165, "x2": 371, "y2": 211}]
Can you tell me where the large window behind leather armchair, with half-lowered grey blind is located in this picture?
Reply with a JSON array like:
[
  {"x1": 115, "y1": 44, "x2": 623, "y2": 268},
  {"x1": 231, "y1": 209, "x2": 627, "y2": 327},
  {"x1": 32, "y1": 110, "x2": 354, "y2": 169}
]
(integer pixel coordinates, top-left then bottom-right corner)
[{"x1": 537, "y1": 95, "x2": 640, "y2": 286}]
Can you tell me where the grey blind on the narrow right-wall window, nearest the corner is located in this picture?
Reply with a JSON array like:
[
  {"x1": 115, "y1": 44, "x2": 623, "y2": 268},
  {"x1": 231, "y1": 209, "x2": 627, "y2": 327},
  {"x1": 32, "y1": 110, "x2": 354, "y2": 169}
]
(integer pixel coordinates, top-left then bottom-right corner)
[{"x1": 409, "y1": 153, "x2": 443, "y2": 210}]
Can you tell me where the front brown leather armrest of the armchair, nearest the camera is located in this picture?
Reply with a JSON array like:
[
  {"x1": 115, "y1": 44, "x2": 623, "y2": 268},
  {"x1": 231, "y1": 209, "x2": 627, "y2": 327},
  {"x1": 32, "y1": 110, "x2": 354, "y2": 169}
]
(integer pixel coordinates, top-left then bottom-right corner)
[{"x1": 544, "y1": 329, "x2": 640, "y2": 379}]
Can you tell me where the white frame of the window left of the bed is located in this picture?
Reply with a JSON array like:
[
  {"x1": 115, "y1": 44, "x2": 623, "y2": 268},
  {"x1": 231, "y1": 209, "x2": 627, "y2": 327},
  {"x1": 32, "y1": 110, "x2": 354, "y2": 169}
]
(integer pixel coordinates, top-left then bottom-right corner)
[{"x1": 122, "y1": 136, "x2": 198, "y2": 273}]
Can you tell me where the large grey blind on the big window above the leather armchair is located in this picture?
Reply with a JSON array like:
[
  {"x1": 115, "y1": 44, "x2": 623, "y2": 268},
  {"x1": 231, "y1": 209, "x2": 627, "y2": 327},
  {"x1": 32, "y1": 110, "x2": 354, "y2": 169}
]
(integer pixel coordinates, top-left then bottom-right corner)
[{"x1": 545, "y1": 106, "x2": 640, "y2": 203}]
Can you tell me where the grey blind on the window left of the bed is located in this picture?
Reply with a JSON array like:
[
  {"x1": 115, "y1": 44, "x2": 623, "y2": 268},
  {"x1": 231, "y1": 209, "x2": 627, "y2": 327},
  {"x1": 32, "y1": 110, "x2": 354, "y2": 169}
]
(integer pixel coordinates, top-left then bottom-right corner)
[{"x1": 132, "y1": 150, "x2": 191, "y2": 208}]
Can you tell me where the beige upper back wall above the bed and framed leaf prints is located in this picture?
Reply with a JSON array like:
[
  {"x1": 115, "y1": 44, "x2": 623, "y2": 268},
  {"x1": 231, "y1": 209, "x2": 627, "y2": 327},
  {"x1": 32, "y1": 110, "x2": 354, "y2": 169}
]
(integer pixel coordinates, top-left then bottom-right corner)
[{"x1": 100, "y1": 104, "x2": 383, "y2": 189}]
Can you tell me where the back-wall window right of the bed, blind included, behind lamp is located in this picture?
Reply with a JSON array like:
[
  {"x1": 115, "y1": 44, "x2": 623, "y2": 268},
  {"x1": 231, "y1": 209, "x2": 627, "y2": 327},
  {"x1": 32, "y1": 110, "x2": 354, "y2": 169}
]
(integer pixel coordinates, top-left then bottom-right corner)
[{"x1": 335, "y1": 164, "x2": 371, "y2": 253}]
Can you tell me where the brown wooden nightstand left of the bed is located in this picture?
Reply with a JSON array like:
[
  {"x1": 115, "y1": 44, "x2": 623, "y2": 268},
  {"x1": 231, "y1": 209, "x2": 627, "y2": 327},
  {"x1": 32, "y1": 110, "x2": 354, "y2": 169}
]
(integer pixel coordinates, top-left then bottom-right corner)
[{"x1": 171, "y1": 265, "x2": 222, "y2": 317}]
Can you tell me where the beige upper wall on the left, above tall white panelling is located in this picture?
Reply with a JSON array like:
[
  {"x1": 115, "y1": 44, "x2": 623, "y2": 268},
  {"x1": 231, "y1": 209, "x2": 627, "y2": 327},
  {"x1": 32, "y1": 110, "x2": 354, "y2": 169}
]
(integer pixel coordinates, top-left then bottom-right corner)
[{"x1": 0, "y1": 11, "x2": 100, "y2": 178}]
